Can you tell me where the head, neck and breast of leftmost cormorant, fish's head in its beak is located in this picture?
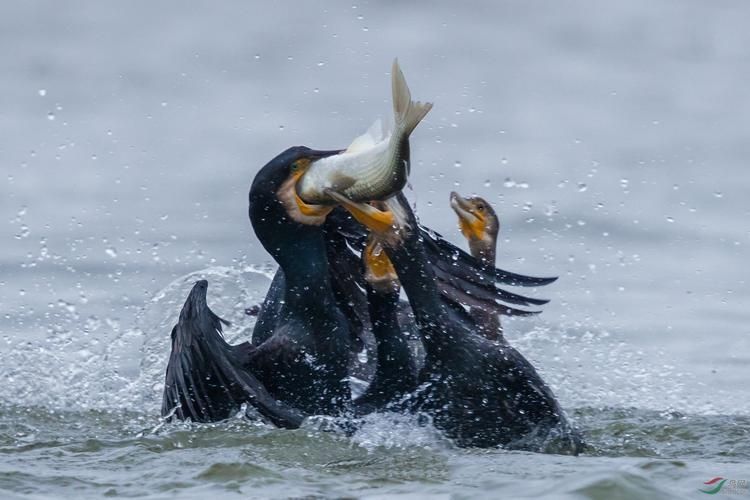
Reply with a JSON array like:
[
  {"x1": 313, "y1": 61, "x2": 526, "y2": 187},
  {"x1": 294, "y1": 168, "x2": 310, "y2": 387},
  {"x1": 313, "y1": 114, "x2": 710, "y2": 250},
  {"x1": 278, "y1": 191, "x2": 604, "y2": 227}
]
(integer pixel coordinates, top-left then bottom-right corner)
[{"x1": 247, "y1": 146, "x2": 351, "y2": 415}]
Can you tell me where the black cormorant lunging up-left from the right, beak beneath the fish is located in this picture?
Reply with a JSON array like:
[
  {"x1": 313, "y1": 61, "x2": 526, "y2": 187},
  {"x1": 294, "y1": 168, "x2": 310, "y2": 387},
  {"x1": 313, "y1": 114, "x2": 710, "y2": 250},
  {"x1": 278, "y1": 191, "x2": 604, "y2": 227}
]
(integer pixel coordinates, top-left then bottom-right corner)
[{"x1": 329, "y1": 191, "x2": 581, "y2": 454}]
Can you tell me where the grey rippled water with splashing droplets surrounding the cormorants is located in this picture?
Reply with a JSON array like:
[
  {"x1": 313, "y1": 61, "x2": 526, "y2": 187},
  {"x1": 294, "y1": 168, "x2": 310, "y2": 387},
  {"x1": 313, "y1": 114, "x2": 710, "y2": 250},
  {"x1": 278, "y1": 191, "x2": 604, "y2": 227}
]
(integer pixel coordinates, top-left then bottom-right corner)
[{"x1": 0, "y1": 1, "x2": 750, "y2": 498}]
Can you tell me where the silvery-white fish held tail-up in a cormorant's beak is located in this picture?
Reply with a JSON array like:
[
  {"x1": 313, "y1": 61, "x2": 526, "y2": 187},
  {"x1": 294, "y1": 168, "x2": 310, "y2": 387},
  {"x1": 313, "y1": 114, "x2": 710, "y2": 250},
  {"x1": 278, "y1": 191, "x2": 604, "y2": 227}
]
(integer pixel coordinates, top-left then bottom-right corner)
[{"x1": 296, "y1": 59, "x2": 432, "y2": 205}]
